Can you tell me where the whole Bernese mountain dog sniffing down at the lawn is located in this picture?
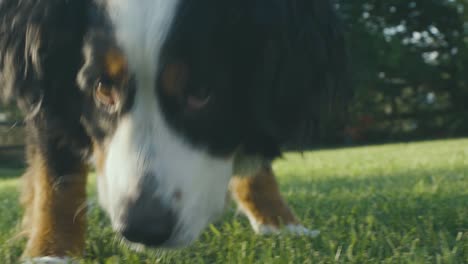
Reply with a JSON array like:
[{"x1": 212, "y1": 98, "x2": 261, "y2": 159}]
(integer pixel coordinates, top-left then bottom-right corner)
[{"x1": 0, "y1": 0, "x2": 348, "y2": 258}]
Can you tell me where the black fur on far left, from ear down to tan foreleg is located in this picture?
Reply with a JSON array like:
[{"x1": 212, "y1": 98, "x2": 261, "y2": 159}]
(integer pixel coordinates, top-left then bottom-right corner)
[{"x1": 0, "y1": 0, "x2": 89, "y2": 179}]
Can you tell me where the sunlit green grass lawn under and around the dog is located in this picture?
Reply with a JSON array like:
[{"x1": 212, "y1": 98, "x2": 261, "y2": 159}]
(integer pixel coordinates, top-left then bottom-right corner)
[{"x1": 0, "y1": 140, "x2": 468, "y2": 263}]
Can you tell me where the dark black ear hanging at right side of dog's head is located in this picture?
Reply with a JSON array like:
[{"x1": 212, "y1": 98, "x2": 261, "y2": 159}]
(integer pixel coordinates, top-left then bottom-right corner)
[{"x1": 249, "y1": 0, "x2": 350, "y2": 148}]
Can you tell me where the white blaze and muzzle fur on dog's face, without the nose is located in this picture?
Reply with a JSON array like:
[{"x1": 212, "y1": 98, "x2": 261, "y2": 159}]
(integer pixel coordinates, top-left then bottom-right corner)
[{"x1": 98, "y1": 0, "x2": 233, "y2": 248}]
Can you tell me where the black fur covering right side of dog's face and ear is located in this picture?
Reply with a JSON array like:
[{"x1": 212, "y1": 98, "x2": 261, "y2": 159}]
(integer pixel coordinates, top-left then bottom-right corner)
[{"x1": 160, "y1": 0, "x2": 350, "y2": 159}]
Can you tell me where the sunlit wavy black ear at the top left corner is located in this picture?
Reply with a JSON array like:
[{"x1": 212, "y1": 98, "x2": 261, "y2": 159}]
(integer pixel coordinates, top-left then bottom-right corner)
[{"x1": 0, "y1": 0, "x2": 90, "y2": 111}]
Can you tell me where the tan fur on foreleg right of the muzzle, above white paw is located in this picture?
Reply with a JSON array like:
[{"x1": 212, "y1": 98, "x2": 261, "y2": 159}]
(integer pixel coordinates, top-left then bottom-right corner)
[{"x1": 230, "y1": 165, "x2": 298, "y2": 227}]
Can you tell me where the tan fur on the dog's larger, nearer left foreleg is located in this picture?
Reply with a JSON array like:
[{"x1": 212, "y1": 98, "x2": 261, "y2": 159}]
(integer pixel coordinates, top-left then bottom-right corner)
[{"x1": 22, "y1": 154, "x2": 87, "y2": 257}]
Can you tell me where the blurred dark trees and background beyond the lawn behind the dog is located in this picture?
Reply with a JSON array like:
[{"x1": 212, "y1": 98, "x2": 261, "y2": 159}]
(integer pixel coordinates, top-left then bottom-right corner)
[{"x1": 0, "y1": 0, "x2": 468, "y2": 165}]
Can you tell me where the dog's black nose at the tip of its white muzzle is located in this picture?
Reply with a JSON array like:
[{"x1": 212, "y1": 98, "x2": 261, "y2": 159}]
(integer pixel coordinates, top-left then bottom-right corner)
[{"x1": 121, "y1": 176, "x2": 176, "y2": 247}]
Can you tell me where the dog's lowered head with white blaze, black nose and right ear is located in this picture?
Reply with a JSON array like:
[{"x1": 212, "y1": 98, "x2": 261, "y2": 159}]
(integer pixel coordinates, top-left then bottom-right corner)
[{"x1": 77, "y1": 0, "x2": 344, "y2": 247}]
